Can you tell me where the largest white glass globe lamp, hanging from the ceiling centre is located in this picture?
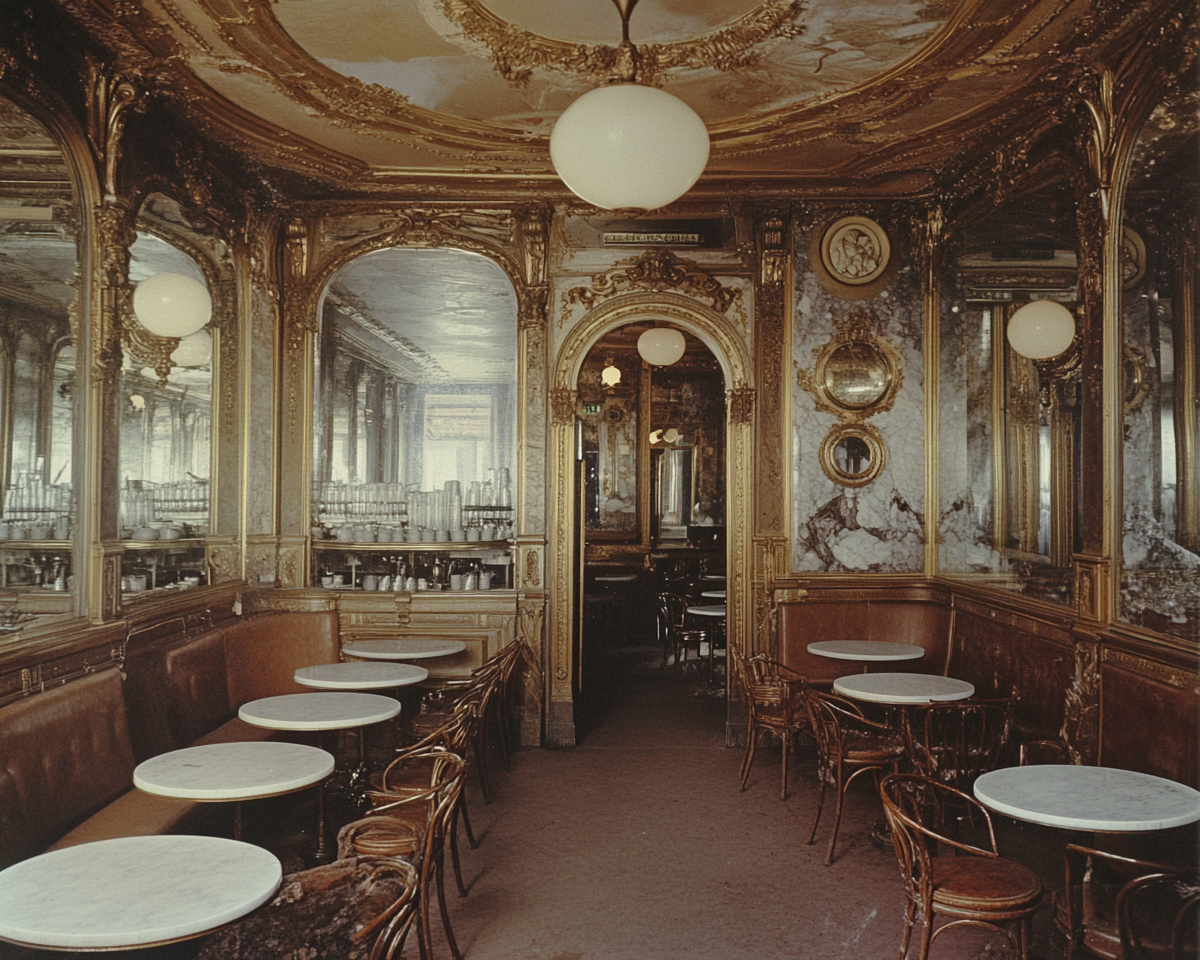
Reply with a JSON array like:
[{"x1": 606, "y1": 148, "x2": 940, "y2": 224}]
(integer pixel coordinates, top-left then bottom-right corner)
[{"x1": 550, "y1": 83, "x2": 708, "y2": 210}]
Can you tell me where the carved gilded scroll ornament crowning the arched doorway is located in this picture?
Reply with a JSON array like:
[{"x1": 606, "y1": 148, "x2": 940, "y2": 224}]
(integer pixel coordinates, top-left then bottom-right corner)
[{"x1": 558, "y1": 250, "x2": 746, "y2": 332}]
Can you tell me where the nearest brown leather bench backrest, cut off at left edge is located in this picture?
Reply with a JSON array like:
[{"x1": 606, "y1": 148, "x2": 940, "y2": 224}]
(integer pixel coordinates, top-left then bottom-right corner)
[{"x1": 0, "y1": 668, "x2": 134, "y2": 866}]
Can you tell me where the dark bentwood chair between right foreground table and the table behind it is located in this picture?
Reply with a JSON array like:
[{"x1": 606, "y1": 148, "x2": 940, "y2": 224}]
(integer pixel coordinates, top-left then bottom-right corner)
[{"x1": 901, "y1": 697, "x2": 1016, "y2": 793}]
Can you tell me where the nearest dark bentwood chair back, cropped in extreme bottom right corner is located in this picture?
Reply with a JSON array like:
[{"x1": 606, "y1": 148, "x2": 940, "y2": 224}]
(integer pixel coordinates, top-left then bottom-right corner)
[{"x1": 1117, "y1": 872, "x2": 1200, "y2": 960}]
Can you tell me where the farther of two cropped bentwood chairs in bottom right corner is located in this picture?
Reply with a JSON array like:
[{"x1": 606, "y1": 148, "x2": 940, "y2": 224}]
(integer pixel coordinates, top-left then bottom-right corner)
[{"x1": 1055, "y1": 844, "x2": 1188, "y2": 960}]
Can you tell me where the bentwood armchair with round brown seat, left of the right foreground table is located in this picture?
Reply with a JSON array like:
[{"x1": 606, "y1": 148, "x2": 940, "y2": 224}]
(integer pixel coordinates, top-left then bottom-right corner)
[{"x1": 880, "y1": 774, "x2": 1042, "y2": 960}]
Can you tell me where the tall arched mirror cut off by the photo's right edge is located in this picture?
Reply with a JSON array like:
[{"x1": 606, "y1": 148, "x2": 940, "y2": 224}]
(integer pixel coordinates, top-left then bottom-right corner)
[{"x1": 1120, "y1": 95, "x2": 1200, "y2": 641}]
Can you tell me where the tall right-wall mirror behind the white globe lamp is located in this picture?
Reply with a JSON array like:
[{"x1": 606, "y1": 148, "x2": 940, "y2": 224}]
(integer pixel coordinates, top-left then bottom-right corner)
[{"x1": 938, "y1": 181, "x2": 1079, "y2": 604}]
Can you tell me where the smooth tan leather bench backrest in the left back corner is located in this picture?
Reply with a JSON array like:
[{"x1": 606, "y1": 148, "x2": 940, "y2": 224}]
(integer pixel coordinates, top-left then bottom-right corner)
[{"x1": 222, "y1": 610, "x2": 341, "y2": 710}]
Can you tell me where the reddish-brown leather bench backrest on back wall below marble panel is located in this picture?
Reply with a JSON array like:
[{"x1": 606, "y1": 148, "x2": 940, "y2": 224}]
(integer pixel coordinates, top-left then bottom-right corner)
[{"x1": 778, "y1": 600, "x2": 950, "y2": 683}]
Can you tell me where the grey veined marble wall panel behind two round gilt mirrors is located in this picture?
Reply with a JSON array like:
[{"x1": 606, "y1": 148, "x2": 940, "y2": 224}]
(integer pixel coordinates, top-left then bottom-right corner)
[{"x1": 791, "y1": 221, "x2": 925, "y2": 574}]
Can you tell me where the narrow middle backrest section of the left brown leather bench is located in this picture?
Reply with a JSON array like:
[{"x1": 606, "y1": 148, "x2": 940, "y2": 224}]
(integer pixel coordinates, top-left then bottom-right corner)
[{"x1": 163, "y1": 630, "x2": 235, "y2": 749}]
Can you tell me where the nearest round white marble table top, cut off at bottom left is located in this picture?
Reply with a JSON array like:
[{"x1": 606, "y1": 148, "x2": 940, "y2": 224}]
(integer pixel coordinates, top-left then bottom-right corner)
[{"x1": 0, "y1": 835, "x2": 283, "y2": 950}]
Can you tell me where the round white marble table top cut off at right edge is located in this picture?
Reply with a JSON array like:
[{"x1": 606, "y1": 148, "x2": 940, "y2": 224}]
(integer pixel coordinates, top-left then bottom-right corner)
[{"x1": 974, "y1": 763, "x2": 1200, "y2": 833}]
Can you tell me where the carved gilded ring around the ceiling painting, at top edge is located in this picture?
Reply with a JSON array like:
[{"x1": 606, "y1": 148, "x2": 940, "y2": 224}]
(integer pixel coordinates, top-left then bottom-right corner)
[{"x1": 438, "y1": 0, "x2": 808, "y2": 86}]
